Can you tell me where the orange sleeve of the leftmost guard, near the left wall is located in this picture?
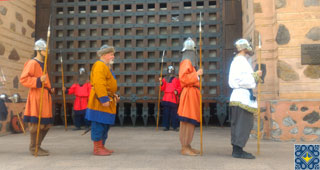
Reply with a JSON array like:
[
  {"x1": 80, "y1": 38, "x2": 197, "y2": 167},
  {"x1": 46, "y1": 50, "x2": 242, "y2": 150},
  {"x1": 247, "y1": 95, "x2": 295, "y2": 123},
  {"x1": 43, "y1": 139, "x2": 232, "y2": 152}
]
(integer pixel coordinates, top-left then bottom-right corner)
[{"x1": 20, "y1": 61, "x2": 38, "y2": 88}]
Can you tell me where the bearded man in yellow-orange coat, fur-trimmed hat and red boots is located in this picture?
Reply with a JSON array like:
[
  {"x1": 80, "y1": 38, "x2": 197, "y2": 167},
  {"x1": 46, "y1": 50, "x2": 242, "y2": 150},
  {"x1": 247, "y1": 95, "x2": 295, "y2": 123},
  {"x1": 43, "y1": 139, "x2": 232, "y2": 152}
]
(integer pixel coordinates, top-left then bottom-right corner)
[{"x1": 86, "y1": 45, "x2": 120, "y2": 156}]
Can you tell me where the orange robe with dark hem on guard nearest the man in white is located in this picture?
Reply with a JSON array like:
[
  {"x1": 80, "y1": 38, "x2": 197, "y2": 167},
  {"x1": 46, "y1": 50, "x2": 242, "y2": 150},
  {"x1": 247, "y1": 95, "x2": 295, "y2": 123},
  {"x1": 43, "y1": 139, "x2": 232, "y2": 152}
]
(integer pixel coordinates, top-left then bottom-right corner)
[{"x1": 178, "y1": 59, "x2": 200, "y2": 125}]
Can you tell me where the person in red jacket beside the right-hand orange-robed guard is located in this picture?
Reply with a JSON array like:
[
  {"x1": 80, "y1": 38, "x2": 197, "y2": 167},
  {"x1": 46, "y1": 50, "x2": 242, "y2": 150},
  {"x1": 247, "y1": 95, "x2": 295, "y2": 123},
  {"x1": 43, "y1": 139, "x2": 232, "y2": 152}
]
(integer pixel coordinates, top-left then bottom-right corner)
[{"x1": 159, "y1": 66, "x2": 182, "y2": 131}]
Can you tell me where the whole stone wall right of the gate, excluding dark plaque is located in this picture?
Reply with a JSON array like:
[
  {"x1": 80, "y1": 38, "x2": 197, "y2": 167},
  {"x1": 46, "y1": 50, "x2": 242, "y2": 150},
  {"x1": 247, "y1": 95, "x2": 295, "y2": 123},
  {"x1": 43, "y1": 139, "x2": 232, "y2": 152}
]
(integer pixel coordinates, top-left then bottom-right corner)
[{"x1": 242, "y1": 0, "x2": 320, "y2": 141}]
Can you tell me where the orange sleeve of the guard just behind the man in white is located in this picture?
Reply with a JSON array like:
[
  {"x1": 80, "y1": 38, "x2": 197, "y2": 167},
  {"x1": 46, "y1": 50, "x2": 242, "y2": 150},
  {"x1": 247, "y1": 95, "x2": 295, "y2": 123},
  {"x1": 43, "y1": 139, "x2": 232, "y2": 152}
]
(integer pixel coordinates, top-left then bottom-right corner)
[{"x1": 179, "y1": 60, "x2": 199, "y2": 87}]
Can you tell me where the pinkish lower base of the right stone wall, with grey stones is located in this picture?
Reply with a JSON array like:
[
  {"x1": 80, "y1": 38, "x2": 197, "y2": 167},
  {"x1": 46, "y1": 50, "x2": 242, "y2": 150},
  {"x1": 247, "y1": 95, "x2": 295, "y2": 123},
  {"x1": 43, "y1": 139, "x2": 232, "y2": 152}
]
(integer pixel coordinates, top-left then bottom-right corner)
[{"x1": 253, "y1": 101, "x2": 320, "y2": 142}]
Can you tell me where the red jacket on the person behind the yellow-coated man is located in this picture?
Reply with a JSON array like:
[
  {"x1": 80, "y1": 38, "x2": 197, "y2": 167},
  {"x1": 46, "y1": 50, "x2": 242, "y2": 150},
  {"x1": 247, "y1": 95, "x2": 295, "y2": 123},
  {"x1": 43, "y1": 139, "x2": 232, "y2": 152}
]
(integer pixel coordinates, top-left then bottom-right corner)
[{"x1": 68, "y1": 83, "x2": 91, "y2": 110}]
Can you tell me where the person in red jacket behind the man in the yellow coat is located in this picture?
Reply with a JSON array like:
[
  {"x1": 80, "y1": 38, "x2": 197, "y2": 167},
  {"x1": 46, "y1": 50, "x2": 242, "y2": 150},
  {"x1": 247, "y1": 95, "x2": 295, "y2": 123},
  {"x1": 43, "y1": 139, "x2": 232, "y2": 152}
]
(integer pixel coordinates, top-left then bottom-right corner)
[{"x1": 64, "y1": 68, "x2": 91, "y2": 130}]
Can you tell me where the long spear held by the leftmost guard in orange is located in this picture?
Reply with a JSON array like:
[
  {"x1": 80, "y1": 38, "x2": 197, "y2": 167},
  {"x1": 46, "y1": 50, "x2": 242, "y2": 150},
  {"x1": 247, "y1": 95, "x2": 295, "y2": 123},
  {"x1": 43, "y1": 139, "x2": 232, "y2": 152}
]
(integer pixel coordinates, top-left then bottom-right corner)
[{"x1": 34, "y1": 16, "x2": 51, "y2": 157}]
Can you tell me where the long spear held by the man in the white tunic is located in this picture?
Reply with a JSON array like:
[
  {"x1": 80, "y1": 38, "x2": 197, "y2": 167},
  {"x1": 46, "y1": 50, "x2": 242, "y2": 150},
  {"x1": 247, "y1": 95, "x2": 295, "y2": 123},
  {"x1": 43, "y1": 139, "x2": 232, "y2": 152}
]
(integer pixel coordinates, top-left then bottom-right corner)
[{"x1": 257, "y1": 33, "x2": 261, "y2": 155}]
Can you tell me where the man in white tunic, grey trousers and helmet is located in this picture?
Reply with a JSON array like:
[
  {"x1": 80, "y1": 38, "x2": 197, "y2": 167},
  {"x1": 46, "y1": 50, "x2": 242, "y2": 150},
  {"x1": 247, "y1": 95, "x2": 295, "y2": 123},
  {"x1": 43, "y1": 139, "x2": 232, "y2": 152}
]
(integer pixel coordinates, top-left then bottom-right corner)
[{"x1": 229, "y1": 39, "x2": 262, "y2": 159}]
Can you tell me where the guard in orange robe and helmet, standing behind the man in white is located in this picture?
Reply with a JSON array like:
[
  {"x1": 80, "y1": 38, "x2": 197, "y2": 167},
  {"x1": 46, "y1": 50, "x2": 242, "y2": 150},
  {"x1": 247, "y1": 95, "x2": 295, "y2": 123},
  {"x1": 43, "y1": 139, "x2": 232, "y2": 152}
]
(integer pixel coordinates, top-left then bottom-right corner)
[{"x1": 178, "y1": 38, "x2": 203, "y2": 156}]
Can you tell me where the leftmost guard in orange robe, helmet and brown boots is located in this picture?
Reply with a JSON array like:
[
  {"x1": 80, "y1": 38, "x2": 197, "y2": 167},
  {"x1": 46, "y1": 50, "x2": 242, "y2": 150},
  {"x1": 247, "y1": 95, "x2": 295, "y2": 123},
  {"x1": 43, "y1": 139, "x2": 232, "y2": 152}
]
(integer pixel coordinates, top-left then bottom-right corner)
[{"x1": 20, "y1": 39, "x2": 54, "y2": 156}]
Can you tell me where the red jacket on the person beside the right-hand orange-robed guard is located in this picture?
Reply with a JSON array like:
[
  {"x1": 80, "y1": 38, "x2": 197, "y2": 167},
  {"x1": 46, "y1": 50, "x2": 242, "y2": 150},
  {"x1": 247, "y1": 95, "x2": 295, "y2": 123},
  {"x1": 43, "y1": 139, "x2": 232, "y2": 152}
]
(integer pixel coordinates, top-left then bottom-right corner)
[{"x1": 161, "y1": 77, "x2": 182, "y2": 104}]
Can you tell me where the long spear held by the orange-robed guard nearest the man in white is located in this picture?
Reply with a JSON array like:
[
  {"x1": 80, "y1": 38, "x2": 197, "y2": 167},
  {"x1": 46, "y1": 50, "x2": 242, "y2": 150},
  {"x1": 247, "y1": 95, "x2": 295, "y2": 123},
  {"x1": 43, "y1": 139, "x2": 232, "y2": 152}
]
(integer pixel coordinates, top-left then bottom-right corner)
[{"x1": 199, "y1": 12, "x2": 203, "y2": 155}]
